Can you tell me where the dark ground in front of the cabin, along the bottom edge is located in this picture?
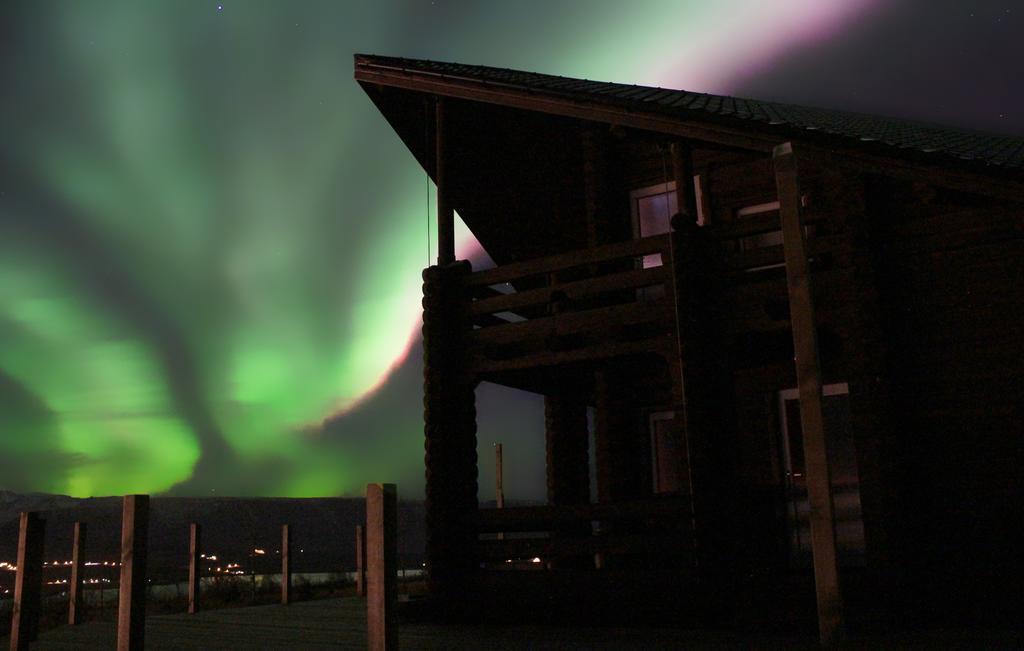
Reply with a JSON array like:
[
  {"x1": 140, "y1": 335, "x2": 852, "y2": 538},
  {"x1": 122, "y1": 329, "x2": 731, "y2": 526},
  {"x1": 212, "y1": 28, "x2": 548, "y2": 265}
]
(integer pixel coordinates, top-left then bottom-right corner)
[{"x1": 0, "y1": 597, "x2": 1024, "y2": 650}]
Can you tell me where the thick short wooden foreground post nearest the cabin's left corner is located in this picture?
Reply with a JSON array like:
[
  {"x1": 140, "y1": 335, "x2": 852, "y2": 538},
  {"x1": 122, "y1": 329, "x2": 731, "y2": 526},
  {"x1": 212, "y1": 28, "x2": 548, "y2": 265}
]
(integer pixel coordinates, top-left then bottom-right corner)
[{"x1": 367, "y1": 484, "x2": 398, "y2": 651}]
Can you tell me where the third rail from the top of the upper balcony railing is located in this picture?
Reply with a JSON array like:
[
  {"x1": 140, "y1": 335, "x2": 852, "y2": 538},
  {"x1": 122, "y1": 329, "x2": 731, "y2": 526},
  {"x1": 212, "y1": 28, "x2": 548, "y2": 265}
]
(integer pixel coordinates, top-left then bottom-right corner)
[{"x1": 471, "y1": 299, "x2": 672, "y2": 344}]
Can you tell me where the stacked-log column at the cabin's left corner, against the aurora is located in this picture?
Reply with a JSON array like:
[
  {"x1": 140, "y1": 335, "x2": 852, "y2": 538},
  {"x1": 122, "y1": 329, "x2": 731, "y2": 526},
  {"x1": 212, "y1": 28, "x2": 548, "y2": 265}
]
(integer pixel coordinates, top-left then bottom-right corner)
[{"x1": 423, "y1": 261, "x2": 477, "y2": 607}]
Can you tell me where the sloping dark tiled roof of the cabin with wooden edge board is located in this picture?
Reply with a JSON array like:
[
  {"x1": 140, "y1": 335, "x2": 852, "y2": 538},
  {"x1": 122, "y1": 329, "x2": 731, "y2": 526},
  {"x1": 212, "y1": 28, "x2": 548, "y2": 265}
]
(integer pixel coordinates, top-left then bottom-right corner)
[{"x1": 355, "y1": 54, "x2": 1024, "y2": 171}]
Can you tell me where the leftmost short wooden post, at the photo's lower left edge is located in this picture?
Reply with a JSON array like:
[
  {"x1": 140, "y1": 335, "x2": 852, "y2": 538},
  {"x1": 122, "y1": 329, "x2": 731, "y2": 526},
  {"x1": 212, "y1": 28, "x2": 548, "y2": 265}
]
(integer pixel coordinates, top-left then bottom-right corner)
[{"x1": 10, "y1": 512, "x2": 46, "y2": 651}]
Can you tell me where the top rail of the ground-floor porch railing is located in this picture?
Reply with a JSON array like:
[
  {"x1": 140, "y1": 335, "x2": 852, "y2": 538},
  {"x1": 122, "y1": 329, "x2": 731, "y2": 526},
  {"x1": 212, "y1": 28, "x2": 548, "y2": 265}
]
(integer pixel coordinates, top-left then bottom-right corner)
[{"x1": 476, "y1": 497, "x2": 690, "y2": 533}]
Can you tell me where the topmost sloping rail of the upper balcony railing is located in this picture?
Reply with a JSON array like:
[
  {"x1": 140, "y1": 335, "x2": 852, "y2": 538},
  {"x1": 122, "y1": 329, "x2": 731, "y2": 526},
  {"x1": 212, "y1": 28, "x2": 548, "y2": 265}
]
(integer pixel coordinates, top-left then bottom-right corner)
[{"x1": 465, "y1": 234, "x2": 669, "y2": 287}]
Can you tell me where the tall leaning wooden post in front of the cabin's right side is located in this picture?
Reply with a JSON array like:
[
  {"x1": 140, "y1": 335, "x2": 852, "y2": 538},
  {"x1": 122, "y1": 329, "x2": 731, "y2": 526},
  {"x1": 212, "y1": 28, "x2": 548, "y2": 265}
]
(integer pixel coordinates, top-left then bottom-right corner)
[{"x1": 773, "y1": 142, "x2": 843, "y2": 645}]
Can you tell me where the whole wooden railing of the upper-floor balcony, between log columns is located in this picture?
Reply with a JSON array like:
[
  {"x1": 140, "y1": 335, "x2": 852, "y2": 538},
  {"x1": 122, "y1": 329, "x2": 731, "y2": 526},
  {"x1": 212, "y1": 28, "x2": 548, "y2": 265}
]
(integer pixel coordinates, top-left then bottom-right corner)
[{"x1": 465, "y1": 234, "x2": 673, "y2": 374}]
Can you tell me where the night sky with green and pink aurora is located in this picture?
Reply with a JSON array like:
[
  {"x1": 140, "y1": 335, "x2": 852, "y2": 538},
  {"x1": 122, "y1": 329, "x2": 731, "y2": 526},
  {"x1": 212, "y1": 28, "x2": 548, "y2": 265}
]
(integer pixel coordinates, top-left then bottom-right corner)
[{"x1": 0, "y1": 0, "x2": 1024, "y2": 500}]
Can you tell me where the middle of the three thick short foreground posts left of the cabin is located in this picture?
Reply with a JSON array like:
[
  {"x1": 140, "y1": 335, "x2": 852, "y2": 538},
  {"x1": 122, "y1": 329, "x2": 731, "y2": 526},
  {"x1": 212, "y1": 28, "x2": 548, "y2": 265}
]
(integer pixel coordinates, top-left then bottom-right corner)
[{"x1": 118, "y1": 495, "x2": 150, "y2": 651}]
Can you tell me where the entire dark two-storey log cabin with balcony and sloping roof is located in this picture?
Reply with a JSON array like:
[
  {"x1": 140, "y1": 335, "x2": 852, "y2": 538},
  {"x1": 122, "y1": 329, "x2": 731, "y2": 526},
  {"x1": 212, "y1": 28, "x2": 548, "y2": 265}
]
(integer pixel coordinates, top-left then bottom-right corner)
[{"x1": 355, "y1": 54, "x2": 1024, "y2": 642}]
